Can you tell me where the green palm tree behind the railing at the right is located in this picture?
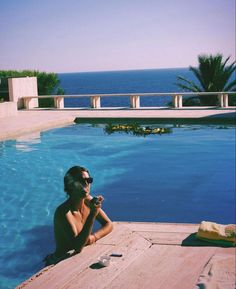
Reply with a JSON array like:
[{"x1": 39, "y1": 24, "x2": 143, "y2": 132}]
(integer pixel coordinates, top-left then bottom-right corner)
[{"x1": 177, "y1": 54, "x2": 236, "y2": 105}]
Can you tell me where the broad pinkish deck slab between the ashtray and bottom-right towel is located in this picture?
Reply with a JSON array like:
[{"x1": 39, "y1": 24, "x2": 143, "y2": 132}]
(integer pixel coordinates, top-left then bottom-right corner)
[{"x1": 102, "y1": 245, "x2": 215, "y2": 289}]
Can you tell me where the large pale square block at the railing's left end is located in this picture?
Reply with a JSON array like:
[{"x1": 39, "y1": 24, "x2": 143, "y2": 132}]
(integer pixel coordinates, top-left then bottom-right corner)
[{"x1": 8, "y1": 77, "x2": 38, "y2": 109}]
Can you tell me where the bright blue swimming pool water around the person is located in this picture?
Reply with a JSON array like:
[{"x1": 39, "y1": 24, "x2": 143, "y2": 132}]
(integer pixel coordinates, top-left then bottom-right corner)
[{"x1": 0, "y1": 123, "x2": 235, "y2": 288}]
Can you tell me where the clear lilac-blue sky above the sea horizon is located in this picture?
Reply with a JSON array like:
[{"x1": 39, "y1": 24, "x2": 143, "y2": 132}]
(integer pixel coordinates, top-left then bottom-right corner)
[{"x1": 0, "y1": 0, "x2": 235, "y2": 72}]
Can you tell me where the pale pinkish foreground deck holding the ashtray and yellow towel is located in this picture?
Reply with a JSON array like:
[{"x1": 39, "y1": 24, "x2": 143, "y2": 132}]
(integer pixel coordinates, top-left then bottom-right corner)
[{"x1": 16, "y1": 222, "x2": 236, "y2": 289}]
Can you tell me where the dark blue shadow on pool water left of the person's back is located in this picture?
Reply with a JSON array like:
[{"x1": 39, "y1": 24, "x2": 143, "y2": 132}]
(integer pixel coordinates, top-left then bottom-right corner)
[{"x1": 1, "y1": 226, "x2": 55, "y2": 280}]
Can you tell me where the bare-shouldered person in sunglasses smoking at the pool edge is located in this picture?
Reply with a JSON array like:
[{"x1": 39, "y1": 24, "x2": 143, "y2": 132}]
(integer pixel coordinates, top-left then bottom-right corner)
[{"x1": 45, "y1": 166, "x2": 113, "y2": 265}]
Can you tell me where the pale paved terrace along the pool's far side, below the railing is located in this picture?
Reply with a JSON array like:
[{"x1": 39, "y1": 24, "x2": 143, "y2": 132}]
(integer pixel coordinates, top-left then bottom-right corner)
[{"x1": 0, "y1": 107, "x2": 236, "y2": 141}]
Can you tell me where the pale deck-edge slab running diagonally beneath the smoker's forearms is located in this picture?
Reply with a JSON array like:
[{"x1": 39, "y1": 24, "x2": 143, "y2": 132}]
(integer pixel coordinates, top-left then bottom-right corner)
[{"x1": 17, "y1": 225, "x2": 150, "y2": 289}]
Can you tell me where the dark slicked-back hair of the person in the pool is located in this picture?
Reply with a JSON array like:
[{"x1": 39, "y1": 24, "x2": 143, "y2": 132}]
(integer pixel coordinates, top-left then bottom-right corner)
[{"x1": 64, "y1": 166, "x2": 89, "y2": 194}]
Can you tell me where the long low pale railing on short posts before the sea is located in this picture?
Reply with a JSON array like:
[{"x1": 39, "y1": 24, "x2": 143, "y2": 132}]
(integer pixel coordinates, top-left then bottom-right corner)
[{"x1": 22, "y1": 91, "x2": 236, "y2": 109}]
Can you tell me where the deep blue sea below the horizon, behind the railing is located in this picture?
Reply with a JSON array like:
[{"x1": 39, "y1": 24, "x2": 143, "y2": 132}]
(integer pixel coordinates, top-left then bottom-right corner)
[{"x1": 58, "y1": 68, "x2": 194, "y2": 107}]
